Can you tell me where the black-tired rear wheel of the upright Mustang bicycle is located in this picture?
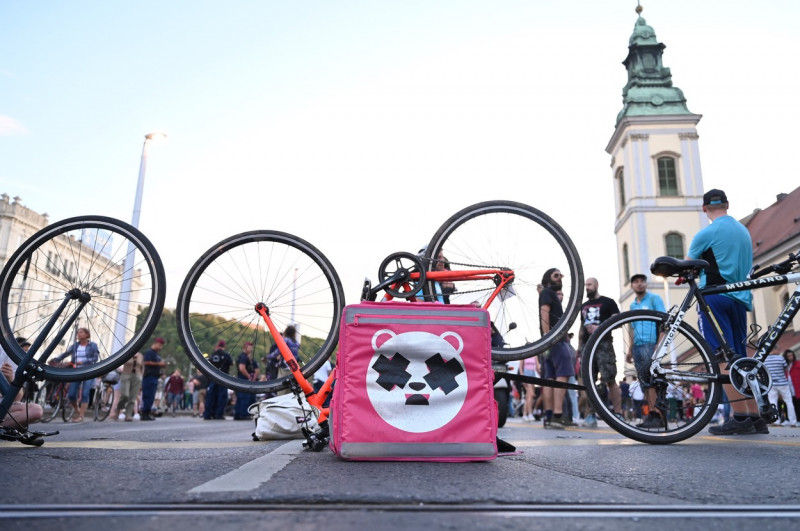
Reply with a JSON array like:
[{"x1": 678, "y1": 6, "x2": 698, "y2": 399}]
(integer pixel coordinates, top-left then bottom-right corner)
[{"x1": 581, "y1": 310, "x2": 722, "y2": 444}]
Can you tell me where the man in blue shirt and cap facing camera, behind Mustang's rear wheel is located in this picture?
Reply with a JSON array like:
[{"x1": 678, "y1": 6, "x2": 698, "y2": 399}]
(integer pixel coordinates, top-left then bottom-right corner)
[{"x1": 625, "y1": 273, "x2": 666, "y2": 428}]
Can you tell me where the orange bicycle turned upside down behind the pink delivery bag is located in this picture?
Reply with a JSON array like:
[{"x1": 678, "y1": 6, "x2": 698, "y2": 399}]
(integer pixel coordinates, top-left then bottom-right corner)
[{"x1": 176, "y1": 201, "x2": 583, "y2": 449}]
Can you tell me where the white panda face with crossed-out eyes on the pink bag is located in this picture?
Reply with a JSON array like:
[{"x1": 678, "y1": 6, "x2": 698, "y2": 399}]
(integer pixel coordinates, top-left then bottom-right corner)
[{"x1": 367, "y1": 330, "x2": 467, "y2": 433}]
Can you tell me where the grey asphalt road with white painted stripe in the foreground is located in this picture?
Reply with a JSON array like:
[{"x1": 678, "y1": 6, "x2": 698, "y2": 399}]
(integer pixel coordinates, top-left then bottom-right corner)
[{"x1": 0, "y1": 416, "x2": 800, "y2": 531}]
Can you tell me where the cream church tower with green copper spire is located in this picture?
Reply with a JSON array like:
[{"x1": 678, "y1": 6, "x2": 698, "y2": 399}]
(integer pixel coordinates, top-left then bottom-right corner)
[{"x1": 606, "y1": 6, "x2": 708, "y2": 311}]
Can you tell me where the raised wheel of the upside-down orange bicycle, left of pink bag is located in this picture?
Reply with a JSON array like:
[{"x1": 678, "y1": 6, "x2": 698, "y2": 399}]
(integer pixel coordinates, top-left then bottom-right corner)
[{"x1": 176, "y1": 230, "x2": 344, "y2": 393}]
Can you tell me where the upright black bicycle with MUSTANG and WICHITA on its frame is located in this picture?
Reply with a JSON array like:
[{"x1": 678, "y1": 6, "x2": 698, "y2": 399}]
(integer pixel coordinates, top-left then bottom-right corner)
[{"x1": 581, "y1": 252, "x2": 800, "y2": 444}]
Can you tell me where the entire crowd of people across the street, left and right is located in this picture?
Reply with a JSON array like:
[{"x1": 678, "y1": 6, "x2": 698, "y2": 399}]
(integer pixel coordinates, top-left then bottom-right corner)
[{"x1": 0, "y1": 190, "x2": 800, "y2": 435}]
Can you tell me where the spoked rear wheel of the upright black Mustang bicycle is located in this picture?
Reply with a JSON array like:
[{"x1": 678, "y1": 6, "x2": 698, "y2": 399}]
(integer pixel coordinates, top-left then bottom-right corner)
[{"x1": 581, "y1": 310, "x2": 722, "y2": 444}]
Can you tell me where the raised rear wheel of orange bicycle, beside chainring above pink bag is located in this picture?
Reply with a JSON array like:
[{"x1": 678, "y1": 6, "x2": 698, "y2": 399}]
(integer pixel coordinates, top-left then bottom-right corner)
[{"x1": 423, "y1": 201, "x2": 583, "y2": 361}]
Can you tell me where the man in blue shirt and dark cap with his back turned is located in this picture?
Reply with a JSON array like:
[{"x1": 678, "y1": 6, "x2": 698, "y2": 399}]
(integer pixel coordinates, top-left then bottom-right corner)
[{"x1": 687, "y1": 189, "x2": 769, "y2": 435}]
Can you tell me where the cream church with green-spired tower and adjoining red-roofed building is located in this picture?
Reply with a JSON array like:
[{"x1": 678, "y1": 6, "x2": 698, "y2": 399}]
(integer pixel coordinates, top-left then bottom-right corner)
[{"x1": 606, "y1": 14, "x2": 800, "y2": 370}]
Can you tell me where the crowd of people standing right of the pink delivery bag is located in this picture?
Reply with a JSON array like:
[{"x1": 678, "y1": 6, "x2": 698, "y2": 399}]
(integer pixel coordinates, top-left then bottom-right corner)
[{"x1": 510, "y1": 189, "x2": 800, "y2": 435}]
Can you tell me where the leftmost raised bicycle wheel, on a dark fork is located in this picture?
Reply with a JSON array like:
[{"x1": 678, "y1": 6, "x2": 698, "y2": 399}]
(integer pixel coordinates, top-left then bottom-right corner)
[{"x1": 0, "y1": 216, "x2": 166, "y2": 382}]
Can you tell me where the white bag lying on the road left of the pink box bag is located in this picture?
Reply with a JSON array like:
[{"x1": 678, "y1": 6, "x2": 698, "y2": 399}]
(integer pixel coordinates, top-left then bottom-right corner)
[{"x1": 247, "y1": 393, "x2": 317, "y2": 441}]
